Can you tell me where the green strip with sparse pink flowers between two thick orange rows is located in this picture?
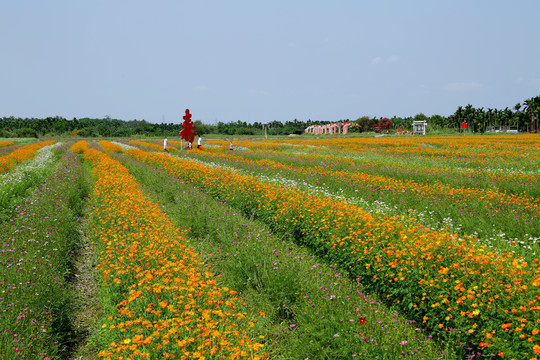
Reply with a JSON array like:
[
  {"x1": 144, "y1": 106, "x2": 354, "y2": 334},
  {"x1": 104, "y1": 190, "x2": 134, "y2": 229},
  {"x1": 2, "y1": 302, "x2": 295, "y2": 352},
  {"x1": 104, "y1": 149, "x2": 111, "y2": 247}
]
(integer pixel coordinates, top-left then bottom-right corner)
[{"x1": 116, "y1": 148, "x2": 456, "y2": 360}]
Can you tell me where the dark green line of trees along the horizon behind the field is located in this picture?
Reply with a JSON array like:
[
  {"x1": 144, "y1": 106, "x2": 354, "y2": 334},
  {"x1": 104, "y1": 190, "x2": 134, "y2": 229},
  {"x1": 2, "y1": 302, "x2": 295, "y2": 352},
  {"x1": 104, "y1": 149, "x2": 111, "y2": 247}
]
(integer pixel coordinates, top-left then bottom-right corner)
[{"x1": 0, "y1": 96, "x2": 540, "y2": 138}]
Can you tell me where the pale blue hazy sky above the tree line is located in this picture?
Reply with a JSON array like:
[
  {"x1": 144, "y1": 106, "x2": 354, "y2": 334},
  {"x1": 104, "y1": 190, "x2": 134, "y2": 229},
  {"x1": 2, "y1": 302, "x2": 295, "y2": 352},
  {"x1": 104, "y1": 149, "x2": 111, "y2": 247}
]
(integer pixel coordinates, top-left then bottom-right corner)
[{"x1": 0, "y1": 0, "x2": 540, "y2": 124}]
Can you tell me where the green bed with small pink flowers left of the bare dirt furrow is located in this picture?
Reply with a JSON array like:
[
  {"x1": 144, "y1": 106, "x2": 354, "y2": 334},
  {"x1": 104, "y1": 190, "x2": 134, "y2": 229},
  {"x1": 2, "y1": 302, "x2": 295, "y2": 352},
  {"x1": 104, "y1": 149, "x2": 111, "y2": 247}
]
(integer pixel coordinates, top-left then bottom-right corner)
[{"x1": 0, "y1": 145, "x2": 86, "y2": 360}]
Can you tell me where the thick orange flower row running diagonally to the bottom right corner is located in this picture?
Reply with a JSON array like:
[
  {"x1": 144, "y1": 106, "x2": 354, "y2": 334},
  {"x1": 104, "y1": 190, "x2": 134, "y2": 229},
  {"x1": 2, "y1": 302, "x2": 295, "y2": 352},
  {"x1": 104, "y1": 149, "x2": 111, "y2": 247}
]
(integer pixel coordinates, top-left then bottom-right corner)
[{"x1": 127, "y1": 149, "x2": 540, "y2": 359}]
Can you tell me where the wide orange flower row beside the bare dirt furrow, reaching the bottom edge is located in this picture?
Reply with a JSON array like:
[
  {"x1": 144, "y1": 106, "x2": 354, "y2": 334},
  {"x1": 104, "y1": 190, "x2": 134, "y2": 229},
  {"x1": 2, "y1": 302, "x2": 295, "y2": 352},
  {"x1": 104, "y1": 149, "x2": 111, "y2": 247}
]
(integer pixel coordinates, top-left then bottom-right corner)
[{"x1": 78, "y1": 148, "x2": 264, "y2": 359}]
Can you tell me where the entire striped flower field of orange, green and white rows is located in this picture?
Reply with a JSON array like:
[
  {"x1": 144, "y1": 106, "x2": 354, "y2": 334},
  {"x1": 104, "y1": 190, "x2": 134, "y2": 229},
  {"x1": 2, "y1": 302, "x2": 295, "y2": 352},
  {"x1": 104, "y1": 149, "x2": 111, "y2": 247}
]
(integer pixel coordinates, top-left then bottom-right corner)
[{"x1": 0, "y1": 135, "x2": 540, "y2": 360}]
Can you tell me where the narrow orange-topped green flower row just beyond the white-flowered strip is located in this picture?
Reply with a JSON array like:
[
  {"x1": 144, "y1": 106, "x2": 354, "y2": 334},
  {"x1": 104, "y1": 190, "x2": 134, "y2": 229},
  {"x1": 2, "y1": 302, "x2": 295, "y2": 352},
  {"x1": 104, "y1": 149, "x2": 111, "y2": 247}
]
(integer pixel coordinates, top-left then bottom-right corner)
[{"x1": 180, "y1": 146, "x2": 540, "y2": 247}]
